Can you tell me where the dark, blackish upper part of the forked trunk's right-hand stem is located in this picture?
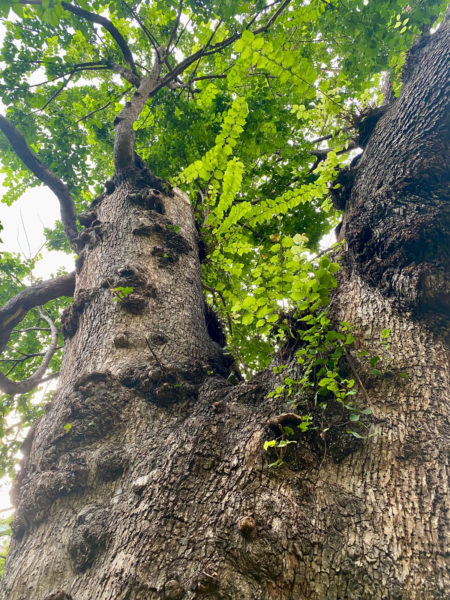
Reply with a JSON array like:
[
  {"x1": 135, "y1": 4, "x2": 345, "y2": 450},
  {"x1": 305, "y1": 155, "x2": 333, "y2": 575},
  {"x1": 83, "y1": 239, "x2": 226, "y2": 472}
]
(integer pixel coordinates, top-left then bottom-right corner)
[{"x1": 340, "y1": 21, "x2": 450, "y2": 340}]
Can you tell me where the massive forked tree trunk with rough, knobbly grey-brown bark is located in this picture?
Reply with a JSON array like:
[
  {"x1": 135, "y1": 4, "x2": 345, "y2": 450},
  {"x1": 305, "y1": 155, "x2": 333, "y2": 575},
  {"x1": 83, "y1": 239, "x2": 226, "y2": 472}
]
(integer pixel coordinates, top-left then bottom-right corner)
[{"x1": 2, "y1": 17, "x2": 450, "y2": 600}]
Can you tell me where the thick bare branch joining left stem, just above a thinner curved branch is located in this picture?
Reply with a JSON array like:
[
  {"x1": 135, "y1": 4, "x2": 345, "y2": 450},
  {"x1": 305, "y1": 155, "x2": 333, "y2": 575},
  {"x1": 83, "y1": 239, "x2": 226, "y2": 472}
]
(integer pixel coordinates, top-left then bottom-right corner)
[{"x1": 0, "y1": 272, "x2": 75, "y2": 352}]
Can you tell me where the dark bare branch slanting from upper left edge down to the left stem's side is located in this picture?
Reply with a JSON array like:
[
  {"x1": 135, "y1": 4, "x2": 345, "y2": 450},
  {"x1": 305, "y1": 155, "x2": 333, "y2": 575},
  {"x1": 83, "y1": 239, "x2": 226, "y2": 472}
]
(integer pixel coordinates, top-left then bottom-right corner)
[{"x1": 0, "y1": 115, "x2": 77, "y2": 245}]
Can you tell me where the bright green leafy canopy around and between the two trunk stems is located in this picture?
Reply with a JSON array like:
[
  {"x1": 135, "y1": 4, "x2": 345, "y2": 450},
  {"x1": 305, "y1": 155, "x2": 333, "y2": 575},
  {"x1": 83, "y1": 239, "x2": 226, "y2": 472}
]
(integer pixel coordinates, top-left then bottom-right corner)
[{"x1": 0, "y1": 0, "x2": 446, "y2": 478}]
